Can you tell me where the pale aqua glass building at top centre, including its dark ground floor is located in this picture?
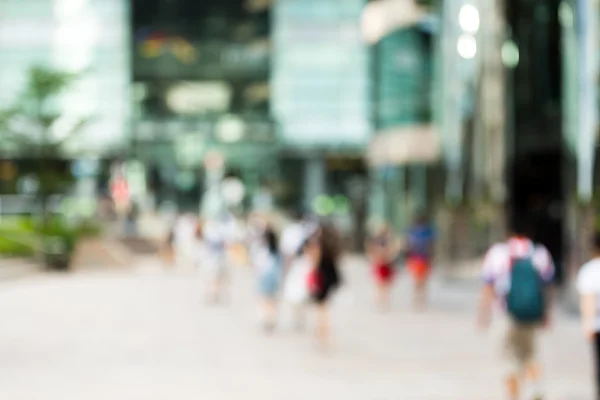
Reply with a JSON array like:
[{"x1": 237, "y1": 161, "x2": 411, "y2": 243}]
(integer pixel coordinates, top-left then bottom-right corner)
[{"x1": 271, "y1": 0, "x2": 371, "y2": 217}]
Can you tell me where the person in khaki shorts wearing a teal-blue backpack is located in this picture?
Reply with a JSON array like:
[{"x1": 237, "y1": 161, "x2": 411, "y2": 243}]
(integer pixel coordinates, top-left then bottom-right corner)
[{"x1": 478, "y1": 225, "x2": 554, "y2": 400}]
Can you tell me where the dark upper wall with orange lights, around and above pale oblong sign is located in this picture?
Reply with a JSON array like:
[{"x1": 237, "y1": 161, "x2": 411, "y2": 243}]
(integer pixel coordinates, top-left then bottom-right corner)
[{"x1": 132, "y1": 0, "x2": 270, "y2": 117}]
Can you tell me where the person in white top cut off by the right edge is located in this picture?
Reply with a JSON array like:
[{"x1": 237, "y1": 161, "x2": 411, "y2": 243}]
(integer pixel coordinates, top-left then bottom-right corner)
[{"x1": 577, "y1": 233, "x2": 600, "y2": 399}]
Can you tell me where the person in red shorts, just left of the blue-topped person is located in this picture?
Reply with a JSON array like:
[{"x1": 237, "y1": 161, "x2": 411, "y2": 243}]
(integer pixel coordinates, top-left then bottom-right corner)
[{"x1": 365, "y1": 224, "x2": 397, "y2": 310}]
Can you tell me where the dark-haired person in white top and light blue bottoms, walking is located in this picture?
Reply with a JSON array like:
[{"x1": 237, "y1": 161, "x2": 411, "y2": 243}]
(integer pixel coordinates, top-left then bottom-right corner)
[{"x1": 251, "y1": 226, "x2": 282, "y2": 332}]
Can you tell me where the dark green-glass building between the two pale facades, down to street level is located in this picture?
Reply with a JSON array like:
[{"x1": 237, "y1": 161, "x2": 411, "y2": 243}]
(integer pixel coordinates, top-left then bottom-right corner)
[{"x1": 132, "y1": 0, "x2": 277, "y2": 211}]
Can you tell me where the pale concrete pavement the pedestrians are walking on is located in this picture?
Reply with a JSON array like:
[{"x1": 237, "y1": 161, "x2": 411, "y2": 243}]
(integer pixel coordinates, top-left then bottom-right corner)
[{"x1": 0, "y1": 259, "x2": 593, "y2": 400}]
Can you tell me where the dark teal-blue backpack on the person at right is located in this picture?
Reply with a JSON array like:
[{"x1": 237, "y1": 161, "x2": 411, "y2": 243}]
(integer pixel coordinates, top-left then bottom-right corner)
[{"x1": 506, "y1": 255, "x2": 546, "y2": 324}]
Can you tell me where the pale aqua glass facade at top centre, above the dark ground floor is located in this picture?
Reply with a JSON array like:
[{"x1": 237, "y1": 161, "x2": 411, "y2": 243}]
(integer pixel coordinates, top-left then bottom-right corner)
[{"x1": 271, "y1": 0, "x2": 371, "y2": 148}]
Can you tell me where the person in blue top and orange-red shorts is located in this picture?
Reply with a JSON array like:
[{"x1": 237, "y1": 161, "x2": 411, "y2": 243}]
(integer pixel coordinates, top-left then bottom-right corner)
[{"x1": 405, "y1": 214, "x2": 435, "y2": 310}]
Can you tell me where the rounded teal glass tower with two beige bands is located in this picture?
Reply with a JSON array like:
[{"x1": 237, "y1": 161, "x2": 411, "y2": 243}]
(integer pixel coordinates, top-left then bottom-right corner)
[{"x1": 362, "y1": 0, "x2": 440, "y2": 229}]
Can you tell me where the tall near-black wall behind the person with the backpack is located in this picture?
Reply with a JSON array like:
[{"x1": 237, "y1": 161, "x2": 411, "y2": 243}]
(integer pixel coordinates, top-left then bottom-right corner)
[{"x1": 506, "y1": 0, "x2": 566, "y2": 281}]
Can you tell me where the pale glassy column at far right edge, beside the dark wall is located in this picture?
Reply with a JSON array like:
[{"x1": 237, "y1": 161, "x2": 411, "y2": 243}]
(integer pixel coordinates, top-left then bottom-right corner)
[{"x1": 559, "y1": 0, "x2": 599, "y2": 296}]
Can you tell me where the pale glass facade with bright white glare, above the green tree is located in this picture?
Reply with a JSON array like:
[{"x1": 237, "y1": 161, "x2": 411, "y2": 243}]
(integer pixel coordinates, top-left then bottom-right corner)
[{"x1": 0, "y1": 0, "x2": 130, "y2": 153}]
